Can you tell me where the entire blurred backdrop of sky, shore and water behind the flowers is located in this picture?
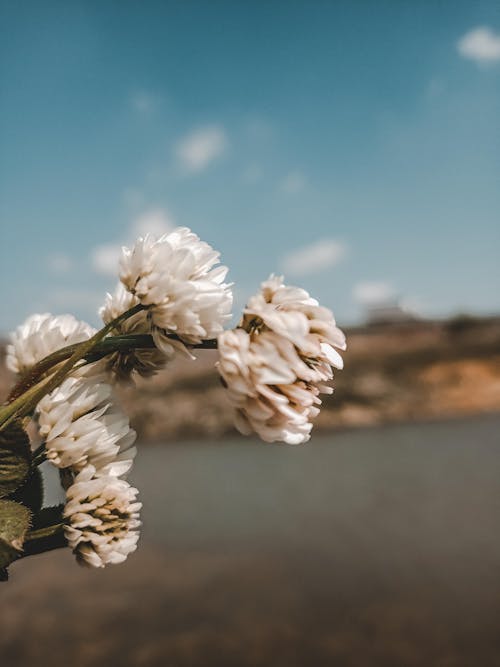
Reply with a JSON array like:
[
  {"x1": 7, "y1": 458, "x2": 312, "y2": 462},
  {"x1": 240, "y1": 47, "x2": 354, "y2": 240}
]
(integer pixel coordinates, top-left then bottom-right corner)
[{"x1": 0, "y1": 0, "x2": 500, "y2": 667}]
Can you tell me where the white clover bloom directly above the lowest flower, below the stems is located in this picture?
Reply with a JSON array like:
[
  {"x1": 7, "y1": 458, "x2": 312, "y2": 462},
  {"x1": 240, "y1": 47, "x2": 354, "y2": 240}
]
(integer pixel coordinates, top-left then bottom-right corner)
[{"x1": 36, "y1": 376, "x2": 136, "y2": 471}]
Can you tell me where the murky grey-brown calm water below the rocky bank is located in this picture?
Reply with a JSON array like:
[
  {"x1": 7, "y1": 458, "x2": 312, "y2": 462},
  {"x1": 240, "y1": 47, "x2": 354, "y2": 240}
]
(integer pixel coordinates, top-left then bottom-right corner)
[{"x1": 0, "y1": 417, "x2": 500, "y2": 667}]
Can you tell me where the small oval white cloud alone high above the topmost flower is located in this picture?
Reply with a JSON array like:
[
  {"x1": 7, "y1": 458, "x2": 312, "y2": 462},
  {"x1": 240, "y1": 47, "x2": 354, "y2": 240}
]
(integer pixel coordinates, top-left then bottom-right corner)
[{"x1": 175, "y1": 125, "x2": 228, "y2": 173}]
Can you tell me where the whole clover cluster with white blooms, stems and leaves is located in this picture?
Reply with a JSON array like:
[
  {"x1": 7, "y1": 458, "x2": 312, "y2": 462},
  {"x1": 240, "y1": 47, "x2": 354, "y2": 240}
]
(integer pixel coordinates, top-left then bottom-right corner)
[{"x1": 0, "y1": 227, "x2": 345, "y2": 580}]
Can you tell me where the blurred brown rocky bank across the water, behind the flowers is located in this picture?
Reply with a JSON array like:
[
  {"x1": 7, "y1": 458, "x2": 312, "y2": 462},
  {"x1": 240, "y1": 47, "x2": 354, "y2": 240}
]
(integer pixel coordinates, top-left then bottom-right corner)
[{"x1": 0, "y1": 317, "x2": 500, "y2": 441}]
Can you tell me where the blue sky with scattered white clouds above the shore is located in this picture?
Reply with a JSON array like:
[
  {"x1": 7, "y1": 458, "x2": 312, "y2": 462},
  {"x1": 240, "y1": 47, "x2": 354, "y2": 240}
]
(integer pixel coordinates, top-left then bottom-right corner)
[{"x1": 0, "y1": 0, "x2": 500, "y2": 332}]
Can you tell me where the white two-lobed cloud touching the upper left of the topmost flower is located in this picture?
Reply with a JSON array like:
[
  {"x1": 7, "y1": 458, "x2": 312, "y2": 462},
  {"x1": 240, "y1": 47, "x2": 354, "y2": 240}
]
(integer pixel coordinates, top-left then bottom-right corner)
[{"x1": 90, "y1": 208, "x2": 175, "y2": 276}]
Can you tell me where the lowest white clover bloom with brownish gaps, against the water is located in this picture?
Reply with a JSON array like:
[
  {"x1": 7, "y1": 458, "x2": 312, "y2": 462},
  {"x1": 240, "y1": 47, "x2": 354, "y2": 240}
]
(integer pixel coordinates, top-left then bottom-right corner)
[{"x1": 64, "y1": 465, "x2": 141, "y2": 567}]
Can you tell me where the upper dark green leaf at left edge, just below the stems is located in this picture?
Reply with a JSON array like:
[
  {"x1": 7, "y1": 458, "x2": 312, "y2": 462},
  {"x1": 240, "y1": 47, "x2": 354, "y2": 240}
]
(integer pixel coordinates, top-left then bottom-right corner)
[{"x1": 0, "y1": 421, "x2": 31, "y2": 498}]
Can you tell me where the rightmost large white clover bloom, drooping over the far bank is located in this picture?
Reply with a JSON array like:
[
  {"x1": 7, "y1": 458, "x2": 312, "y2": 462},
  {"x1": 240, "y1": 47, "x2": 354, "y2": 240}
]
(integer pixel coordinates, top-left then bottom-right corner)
[{"x1": 218, "y1": 276, "x2": 345, "y2": 444}]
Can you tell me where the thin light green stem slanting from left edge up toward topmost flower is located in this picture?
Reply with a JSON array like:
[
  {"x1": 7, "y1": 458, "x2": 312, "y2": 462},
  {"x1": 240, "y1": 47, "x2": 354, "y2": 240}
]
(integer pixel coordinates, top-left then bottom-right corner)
[{"x1": 0, "y1": 304, "x2": 145, "y2": 430}]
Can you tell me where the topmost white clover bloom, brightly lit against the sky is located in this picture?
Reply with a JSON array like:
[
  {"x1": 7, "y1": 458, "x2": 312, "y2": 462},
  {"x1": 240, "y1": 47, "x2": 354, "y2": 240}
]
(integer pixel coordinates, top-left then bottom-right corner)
[{"x1": 120, "y1": 227, "x2": 232, "y2": 354}]
